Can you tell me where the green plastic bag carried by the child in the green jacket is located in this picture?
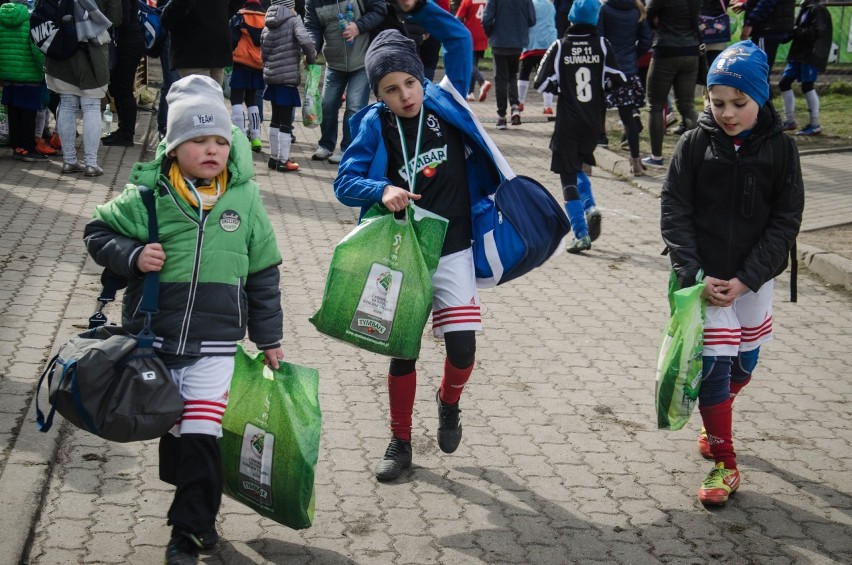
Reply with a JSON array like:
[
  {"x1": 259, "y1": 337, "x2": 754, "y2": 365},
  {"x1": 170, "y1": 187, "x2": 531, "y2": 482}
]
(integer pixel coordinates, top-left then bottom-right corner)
[{"x1": 220, "y1": 346, "x2": 322, "y2": 530}]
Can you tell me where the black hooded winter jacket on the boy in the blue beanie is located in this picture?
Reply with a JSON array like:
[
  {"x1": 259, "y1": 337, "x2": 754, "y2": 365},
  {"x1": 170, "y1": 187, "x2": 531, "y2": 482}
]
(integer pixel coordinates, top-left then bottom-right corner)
[{"x1": 660, "y1": 104, "x2": 805, "y2": 292}]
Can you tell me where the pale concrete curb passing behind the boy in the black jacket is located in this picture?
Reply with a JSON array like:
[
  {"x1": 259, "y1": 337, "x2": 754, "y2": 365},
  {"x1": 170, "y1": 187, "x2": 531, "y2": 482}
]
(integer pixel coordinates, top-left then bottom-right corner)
[{"x1": 595, "y1": 147, "x2": 852, "y2": 291}]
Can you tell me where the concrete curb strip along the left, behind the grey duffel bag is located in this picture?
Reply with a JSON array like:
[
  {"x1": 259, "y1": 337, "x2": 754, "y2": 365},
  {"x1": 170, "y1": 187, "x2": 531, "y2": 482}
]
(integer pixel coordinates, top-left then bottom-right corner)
[{"x1": 0, "y1": 112, "x2": 155, "y2": 565}]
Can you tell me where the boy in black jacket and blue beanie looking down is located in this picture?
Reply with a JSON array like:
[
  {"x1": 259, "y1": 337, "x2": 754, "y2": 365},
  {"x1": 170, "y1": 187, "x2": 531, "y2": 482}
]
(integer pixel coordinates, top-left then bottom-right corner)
[{"x1": 661, "y1": 41, "x2": 805, "y2": 505}]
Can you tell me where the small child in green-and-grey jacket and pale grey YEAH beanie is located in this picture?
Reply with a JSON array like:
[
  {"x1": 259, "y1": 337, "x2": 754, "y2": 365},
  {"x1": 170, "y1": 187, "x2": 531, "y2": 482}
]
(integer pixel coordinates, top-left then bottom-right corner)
[{"x1": 85, "y1": 75, "x2": 283, "y2": 564}]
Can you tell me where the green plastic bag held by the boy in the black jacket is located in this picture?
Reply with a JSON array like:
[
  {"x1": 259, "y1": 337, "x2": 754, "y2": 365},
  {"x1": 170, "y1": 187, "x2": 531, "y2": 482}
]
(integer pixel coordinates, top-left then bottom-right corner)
[{"x1": 656, "y1": 273, "x2": 706, "y2": 430}]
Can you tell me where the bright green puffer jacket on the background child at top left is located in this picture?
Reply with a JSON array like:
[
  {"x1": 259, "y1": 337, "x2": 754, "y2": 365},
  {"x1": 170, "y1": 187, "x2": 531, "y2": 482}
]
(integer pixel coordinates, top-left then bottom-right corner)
[{"x1": 0, "y1": 4, "x2": 44, "y2": 84}]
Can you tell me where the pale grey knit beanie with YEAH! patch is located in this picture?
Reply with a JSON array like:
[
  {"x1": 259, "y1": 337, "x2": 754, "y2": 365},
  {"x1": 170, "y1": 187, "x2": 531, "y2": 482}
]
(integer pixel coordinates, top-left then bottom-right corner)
[{"x1": 166, "y1": 75, "x2": 231, "y2": 154}]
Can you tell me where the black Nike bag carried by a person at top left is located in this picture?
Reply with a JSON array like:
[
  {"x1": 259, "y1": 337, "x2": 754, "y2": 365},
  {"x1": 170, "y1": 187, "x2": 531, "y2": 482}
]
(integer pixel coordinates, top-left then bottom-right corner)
[{"x1": 30, "y1": 0, "x2": 80, "y2": 61}]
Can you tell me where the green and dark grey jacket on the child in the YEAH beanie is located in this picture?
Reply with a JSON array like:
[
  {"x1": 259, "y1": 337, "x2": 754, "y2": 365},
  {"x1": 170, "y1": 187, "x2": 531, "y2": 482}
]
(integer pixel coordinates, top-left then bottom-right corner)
[{"x1": 84, "y1": 128, "x2": 283, "y2": 356}]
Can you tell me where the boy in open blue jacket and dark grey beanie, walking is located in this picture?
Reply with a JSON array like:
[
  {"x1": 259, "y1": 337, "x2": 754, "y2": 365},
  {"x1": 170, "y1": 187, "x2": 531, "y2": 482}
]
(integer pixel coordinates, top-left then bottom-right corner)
[{"x1": 334, "y1": 0, "x2": 512, "y2": 480}]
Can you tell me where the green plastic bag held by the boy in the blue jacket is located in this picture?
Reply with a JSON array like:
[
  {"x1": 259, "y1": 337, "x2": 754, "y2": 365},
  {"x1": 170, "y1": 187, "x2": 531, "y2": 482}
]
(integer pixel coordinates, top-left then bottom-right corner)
[{"x1": 310, "y1": 204, "x2": 447, "y2": 359}]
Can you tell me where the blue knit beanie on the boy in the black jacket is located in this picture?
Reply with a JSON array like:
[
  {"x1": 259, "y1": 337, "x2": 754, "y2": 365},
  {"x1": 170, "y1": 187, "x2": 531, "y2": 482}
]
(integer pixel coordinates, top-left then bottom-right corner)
[{"x1": 707, "y1": 39, "x2": 769, "y2": 106}]
